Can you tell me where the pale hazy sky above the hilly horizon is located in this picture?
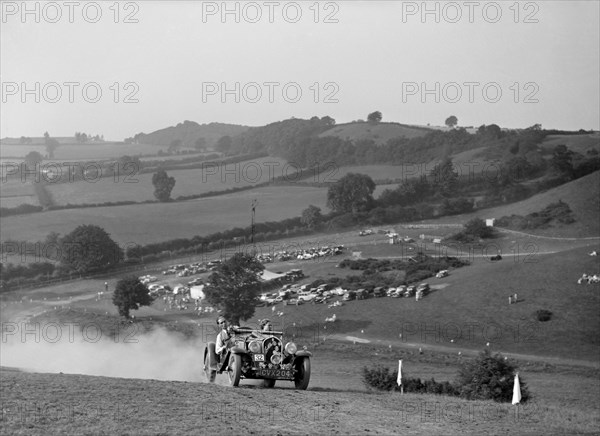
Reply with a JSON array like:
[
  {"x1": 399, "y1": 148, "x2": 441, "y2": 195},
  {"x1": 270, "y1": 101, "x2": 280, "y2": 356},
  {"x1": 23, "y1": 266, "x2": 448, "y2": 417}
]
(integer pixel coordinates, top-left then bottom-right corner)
[{"x1": 0, "y1": 1, "x2": 600, "y2": 140}]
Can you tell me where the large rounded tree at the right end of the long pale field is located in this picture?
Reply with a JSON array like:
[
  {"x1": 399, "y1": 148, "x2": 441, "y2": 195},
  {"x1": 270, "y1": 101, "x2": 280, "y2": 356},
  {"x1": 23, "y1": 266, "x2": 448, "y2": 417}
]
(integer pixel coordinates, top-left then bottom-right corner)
[{"x1": 327, "y1": 173, "x2": 375, "y2": 213}]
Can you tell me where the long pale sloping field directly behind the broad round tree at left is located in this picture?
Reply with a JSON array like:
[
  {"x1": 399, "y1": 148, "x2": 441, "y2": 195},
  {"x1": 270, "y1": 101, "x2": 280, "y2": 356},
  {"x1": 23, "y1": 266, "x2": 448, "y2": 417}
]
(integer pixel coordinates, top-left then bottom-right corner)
[{"x1": 2, "y1": 186, "x2": 328, "y2": 244}]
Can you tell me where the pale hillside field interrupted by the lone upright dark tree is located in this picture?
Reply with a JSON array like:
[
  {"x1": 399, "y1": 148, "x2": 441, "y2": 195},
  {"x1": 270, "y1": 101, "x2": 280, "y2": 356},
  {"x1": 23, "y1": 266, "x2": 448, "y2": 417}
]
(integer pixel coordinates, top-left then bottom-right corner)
[{"x1": 48, "y1": 158, "x2": 296, "y2": 205}]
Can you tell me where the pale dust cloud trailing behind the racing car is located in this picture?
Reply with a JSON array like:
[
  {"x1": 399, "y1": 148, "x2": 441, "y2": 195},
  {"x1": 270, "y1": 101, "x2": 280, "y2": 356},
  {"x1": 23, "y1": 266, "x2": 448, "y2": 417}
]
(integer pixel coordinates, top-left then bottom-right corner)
[{"x1": 0, "y1": 323, "x2": 206, "y2": 382}]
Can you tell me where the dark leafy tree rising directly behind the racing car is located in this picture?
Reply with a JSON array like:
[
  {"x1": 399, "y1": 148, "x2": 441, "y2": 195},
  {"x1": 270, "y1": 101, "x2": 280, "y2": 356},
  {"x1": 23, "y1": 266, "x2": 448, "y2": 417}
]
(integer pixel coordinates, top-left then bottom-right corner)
[{"x1": 204, "y1": 253, "x2": 265, "y2": 325}]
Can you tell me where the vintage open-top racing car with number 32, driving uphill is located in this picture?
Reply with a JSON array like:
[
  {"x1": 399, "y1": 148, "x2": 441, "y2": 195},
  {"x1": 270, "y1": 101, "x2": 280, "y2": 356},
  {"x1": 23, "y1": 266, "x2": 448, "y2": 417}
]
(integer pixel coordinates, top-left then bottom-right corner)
[{"x1": 204, "y1": 327, "x2": 312, "y2": 390}]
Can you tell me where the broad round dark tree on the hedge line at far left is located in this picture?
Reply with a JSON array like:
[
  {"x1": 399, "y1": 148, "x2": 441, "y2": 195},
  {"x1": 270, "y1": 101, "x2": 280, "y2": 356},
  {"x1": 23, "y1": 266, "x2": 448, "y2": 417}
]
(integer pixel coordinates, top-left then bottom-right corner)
[{"x1": 60, "y1": 224, "x2": 123, "y2": 274}]
